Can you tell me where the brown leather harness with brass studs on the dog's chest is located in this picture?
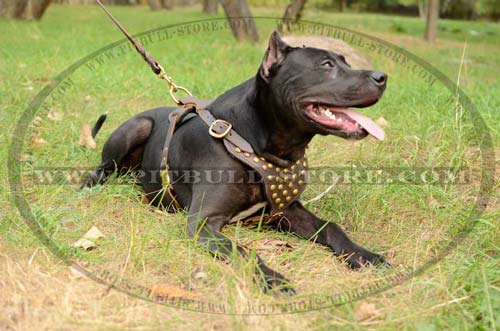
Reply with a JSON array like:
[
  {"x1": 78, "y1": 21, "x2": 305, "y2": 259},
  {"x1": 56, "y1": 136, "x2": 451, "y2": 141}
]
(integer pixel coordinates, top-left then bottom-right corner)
[{"x1": 161, "y1": 98, "x2": 307, "y2": 218}]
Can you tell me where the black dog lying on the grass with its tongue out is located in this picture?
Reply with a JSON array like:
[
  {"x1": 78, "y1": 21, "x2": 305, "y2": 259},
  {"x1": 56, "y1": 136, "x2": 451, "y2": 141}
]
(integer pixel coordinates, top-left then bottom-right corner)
[{"x1": 84, "y1": 32, "x2": 388, "y2": 294}]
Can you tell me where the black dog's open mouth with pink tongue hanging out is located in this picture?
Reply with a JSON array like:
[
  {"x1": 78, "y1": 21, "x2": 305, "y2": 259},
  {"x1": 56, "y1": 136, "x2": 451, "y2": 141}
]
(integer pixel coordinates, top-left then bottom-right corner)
[{"x1": 306, "y1": 103, "x2": 385, "y2": 140}]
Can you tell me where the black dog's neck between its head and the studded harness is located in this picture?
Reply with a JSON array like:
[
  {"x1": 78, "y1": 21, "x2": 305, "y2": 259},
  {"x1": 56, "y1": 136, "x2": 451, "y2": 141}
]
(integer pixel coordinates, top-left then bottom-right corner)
[{"x1": 208, "y1": 77, "x2": 313, "y2": 161}]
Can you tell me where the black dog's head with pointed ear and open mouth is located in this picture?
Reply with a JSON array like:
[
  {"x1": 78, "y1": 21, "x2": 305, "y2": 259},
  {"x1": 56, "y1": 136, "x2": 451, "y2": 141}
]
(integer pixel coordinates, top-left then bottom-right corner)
[{"x1": 258, "y1": 31, "x2": 387, "y2": 140}]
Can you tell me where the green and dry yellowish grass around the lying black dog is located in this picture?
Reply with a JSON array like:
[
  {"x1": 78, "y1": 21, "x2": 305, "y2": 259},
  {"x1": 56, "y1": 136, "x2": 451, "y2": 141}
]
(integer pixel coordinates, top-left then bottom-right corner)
[{"x1": 0, "y1": 6, "x2": 500, "y2": 330}]
